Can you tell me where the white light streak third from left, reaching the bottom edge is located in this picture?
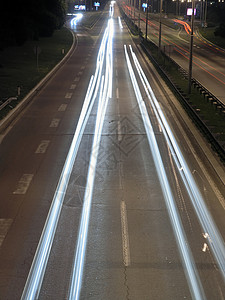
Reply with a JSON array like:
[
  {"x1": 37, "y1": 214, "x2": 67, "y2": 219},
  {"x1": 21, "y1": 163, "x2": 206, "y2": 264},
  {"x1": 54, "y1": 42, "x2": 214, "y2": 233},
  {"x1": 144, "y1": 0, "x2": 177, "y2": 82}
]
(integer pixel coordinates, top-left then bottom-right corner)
[{"x1": 125, "y1": 46, "x2": 206, "y2": 300}]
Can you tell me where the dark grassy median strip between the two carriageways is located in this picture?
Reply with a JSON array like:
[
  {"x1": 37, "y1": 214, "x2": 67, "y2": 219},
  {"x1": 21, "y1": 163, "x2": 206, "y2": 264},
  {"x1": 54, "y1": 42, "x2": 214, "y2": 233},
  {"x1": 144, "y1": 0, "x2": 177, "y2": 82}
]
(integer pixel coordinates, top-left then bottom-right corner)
[{"x1": 122, "y1": 10, "x2": 225, "y2": 162}]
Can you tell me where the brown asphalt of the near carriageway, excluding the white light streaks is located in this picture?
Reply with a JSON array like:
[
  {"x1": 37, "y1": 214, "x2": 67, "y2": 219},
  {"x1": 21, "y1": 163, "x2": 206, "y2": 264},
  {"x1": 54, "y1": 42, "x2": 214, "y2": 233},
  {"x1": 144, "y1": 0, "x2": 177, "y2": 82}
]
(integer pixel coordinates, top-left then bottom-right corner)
[{"x1": 0, "y1": 5, "x2": 225, "y2": 300}]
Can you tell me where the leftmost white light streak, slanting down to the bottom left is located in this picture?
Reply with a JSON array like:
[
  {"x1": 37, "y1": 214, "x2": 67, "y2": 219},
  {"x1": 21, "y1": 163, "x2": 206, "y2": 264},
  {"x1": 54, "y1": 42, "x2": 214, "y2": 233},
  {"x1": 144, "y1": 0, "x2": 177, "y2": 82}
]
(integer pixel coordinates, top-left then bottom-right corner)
[{"x1": 21, "y1": 11, "x2": 112, "y2": 300}]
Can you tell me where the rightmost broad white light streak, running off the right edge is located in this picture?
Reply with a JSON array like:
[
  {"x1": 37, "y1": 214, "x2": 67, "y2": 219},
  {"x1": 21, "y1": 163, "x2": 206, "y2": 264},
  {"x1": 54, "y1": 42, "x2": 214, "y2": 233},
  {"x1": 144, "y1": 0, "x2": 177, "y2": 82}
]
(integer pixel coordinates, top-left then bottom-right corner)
[{"x1": 128, "y1": 45, "x2": 225, "y2": 280}]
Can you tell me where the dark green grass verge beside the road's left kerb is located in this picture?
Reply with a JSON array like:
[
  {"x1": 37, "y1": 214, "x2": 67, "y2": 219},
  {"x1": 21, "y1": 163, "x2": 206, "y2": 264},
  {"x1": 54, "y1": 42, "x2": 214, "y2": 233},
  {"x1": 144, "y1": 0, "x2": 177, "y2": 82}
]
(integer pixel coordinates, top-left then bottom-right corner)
[{"x1": 0, "y1": 27, "x2": 73, "y2": 119}]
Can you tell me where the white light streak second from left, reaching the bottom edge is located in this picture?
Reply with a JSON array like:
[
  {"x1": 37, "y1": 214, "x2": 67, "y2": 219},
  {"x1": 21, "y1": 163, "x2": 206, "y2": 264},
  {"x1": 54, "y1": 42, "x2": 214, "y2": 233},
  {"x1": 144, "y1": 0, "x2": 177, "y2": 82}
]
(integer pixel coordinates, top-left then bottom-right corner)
[{"x1": 68, "y1": 19, "x2": 113, "y2": 300}]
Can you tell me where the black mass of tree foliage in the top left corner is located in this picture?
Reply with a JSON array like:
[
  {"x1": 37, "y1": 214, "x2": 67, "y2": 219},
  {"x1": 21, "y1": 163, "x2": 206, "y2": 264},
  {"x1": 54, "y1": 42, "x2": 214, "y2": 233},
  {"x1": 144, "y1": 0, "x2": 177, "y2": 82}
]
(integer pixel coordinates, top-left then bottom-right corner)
[{"x1": 0, "y1": 0, "x2": 66, "y2": 49}]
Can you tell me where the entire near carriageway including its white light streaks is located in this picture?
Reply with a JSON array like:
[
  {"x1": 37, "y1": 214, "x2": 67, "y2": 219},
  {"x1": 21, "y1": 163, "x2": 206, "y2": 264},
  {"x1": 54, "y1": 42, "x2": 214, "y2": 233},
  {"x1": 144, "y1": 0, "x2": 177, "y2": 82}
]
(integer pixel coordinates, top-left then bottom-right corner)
[{"x1": 0, "y1": 2, "x2": 225, "y2": 300}]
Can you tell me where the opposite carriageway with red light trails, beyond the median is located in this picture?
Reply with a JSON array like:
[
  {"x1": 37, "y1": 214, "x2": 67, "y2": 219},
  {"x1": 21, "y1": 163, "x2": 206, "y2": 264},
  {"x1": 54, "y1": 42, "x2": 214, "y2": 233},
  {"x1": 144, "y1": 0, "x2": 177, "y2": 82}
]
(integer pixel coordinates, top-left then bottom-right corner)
[{"x1": 124, "y1": 2, "x2": 225, "y2": 103}]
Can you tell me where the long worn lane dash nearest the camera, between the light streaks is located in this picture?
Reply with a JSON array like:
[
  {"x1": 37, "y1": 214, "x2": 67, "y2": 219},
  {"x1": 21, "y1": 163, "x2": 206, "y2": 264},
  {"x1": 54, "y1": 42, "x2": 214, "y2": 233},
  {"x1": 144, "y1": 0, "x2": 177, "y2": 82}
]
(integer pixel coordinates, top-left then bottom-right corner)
[{"x1": 120, "y1": 201, "x2": 130, "y2": 267}]
